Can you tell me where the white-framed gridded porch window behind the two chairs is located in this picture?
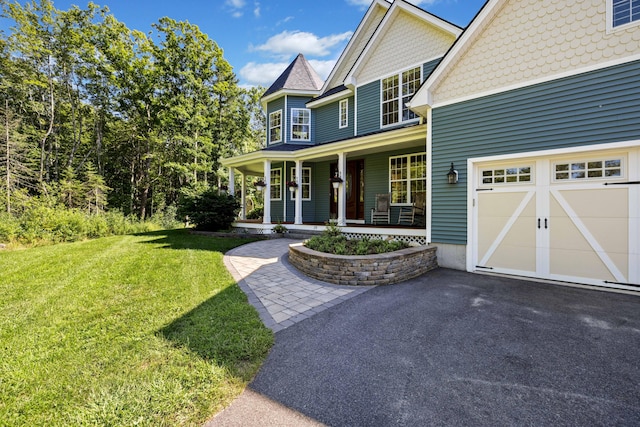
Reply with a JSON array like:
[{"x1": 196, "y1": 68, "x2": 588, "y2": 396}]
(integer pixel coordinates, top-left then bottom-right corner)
[{"x1": 389, "y1": 153, "x2": 427, "y2": 204}]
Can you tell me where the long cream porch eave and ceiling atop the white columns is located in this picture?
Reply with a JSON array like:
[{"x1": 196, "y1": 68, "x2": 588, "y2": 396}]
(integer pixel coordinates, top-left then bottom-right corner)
[{"x1": 221, "y1": 124, "x2": 427, "y2": 176}]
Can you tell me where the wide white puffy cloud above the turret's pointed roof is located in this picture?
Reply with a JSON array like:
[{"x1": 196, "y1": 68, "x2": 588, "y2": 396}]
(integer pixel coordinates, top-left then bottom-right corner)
[{"x1": 253, "y1": 31, "x2": 353, "y2": 56}]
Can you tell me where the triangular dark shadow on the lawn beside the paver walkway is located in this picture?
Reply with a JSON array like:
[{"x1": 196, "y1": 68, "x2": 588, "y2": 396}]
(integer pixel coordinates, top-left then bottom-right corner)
[{"x1": 158, "y1": 284, "x2": 274, "y2": 380}]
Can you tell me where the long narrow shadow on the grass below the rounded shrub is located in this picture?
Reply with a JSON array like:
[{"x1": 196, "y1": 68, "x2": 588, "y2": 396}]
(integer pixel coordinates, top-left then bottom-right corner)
[{"x1": 136, "y1": 228, "x2": 258, "y2": 253}]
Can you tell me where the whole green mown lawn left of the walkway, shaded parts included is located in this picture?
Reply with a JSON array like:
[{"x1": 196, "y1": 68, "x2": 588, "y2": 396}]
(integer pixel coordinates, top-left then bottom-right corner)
[{"x1": 0, "y1": 230, "x2": 273, "y2": 426}]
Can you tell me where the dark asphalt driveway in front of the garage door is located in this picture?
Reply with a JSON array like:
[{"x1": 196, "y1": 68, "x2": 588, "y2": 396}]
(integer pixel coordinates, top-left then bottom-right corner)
[{"x1": 250, "y1": 269, "x2": 640, "y2": 426}]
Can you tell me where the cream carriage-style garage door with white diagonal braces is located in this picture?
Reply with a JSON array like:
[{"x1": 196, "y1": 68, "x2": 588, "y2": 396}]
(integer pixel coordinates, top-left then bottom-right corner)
[{"x1": 471, "y1": 149, "x2": 640, "y2": 290}]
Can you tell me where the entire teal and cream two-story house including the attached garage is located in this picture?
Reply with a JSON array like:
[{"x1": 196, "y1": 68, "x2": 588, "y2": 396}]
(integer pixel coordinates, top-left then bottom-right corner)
[{"x1": 223, "y1": 0, "x2": 640, "y2": 290}]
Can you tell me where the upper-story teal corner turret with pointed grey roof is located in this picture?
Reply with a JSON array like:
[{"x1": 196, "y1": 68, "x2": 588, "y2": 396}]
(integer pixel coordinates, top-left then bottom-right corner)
[{"x1": 262, "y1": 54, "x2": 324, "y2": 146}]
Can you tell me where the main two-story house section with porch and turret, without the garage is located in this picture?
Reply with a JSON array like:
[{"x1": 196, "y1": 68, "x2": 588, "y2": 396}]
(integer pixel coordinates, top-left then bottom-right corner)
[{"x1": 222, "y1": 0, "x2": 462, "y2": 244}]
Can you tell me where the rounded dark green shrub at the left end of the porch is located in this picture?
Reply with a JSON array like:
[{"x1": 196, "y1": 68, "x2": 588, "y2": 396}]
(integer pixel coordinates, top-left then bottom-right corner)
[{"x1": 179, "y1": 190, "x2": 240, "y2": 231}]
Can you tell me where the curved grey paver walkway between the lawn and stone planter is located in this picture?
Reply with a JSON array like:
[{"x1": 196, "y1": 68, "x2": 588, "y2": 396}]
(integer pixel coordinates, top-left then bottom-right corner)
[{"x1": 224, "y1": 239, "x2": 373, "y2": 332}]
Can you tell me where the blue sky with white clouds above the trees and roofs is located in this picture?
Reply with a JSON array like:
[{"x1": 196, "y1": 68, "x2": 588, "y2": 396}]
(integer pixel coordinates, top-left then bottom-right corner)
[{"x1": 6, "y1": 0, "x2": 485, "y2": 86}]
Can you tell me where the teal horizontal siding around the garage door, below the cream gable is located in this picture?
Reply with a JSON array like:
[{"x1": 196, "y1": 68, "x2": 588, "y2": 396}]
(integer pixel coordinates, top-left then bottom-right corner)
[{"x1": 432, "y1": 61, "x2": 640, "y2": 244}]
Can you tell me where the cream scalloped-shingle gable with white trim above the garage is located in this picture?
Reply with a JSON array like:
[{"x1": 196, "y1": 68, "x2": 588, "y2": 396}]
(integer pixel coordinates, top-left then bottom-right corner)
[{"x1": 409, "y1": 0, "x2": 640, "y2": 113}]
